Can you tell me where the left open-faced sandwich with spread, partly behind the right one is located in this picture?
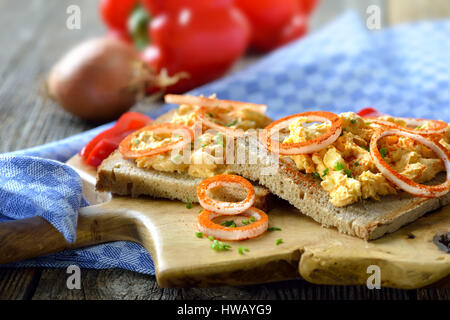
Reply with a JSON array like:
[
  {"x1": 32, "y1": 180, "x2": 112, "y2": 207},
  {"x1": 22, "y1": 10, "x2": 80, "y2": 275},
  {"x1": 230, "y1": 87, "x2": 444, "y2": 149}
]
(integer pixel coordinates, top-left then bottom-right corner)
[{"x1": 96, "y1": 95, "x2": 272, "y2": 208}]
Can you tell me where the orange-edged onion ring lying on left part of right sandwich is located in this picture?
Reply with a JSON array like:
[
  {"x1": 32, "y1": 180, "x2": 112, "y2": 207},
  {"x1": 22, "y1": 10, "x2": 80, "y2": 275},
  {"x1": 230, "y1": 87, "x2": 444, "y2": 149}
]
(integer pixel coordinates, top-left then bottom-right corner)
[{"x1": 261, "y1": 111, "x2": 342, "y2": 155}]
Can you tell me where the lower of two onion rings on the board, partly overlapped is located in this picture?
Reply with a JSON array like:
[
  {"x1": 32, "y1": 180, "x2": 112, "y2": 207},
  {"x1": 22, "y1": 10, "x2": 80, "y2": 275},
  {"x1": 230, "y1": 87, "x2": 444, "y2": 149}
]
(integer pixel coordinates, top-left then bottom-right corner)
[{"x1": 197, "y1": 207, "x2": 269, "y2": 241}]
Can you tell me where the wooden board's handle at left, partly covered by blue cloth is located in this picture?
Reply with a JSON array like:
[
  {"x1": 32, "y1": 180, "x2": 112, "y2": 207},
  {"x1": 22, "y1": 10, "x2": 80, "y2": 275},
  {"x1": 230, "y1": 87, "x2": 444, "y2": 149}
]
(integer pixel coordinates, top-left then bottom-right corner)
[{"x1": 0, "y1": 205, "x2": 140, "y2": 264}]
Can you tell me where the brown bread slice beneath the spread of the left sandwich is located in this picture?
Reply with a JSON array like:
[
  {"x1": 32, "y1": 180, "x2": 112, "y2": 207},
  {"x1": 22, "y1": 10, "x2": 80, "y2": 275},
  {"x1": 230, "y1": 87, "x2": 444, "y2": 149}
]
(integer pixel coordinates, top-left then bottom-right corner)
[{"x1": 96, "y1": 151, "x2": 273, "y2": 210}]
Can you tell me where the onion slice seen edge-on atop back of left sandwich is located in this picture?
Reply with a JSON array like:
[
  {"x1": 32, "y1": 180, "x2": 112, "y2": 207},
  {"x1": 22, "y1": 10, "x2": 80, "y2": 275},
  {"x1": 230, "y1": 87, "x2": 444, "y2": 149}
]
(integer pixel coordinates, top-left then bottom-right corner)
[{"x1": 164, "y1": 94, "x2": 267, "y2": 113}]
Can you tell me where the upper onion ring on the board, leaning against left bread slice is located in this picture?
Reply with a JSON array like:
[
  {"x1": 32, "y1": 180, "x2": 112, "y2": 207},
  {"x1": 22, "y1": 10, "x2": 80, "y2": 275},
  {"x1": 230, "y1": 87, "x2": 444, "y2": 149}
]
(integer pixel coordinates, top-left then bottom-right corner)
[{"x1": 197, "y1": 174, "x2": 255, "y2": 215}]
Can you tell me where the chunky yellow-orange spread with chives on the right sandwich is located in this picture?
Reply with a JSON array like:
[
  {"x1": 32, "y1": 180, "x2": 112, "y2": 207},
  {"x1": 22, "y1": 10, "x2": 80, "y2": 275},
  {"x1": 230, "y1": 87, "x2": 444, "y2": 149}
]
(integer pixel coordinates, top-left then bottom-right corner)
[{"x1": 283, "y1": 112, "x2": 450, "y2": 207}]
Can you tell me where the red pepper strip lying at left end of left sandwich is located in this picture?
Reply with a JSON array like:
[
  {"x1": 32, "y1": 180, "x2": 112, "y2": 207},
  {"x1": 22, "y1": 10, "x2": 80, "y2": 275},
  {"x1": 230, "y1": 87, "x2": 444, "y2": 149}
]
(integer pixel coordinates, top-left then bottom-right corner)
[{"x1": 80, "y1": 112, "x2": 152, "y2": 167}]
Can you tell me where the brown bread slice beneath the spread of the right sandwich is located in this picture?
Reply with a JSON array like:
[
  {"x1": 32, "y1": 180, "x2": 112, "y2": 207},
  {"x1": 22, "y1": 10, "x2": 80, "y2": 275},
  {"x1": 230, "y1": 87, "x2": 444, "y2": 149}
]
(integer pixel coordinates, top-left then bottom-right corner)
[{"x1": 231, "y1": 138, "x2": 450, "y2": 240}]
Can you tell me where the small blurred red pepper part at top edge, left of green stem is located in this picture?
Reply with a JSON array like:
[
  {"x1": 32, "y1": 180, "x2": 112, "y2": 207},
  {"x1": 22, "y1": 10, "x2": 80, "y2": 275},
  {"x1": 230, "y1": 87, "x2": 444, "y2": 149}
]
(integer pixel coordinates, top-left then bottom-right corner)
[{"x1": 100, "y1": 0, "x2": 139, "y2": 32}]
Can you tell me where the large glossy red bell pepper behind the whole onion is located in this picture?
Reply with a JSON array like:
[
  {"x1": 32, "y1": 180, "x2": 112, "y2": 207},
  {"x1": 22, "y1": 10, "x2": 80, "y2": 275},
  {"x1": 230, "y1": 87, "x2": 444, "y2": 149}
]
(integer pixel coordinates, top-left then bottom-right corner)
[{"x1": 142, "y1": 0, "x2": 250, "y2": 92}]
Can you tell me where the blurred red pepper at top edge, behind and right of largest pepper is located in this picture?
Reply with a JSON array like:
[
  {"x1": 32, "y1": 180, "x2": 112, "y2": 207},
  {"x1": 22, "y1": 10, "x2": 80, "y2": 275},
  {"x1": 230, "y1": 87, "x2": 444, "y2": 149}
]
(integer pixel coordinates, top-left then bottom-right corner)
[{"x1": 236, "y1": 0, "x2": 299, "y2": 51}]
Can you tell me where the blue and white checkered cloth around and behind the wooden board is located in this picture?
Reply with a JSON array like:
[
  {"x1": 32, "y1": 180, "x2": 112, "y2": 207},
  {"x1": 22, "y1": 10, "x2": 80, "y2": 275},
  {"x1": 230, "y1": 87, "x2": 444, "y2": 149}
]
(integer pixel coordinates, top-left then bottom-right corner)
[{"x1": 0, "y1": 12, "x2": 450, "y2": 274}]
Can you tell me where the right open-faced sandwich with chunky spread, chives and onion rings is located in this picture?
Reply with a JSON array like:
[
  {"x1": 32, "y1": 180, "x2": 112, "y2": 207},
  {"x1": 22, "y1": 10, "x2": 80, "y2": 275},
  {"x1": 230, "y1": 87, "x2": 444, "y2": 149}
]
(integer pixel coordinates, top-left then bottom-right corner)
[{"x1": 233, "y1": 112, "x2": 450, "y2": 240}]
